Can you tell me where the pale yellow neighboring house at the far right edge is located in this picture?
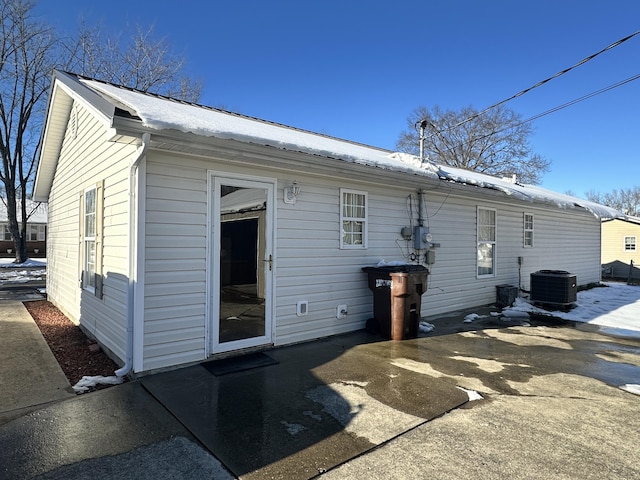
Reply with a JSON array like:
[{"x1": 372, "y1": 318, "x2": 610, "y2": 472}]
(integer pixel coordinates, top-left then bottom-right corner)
[{"x1": 602, "y1": 216, "x2": 640, "y2": 280}]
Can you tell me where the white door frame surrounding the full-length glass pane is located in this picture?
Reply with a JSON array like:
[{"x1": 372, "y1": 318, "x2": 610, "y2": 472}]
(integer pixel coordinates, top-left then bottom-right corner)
[{"x1": 205, "y1": 170, "x2": 277, "y2": 357}]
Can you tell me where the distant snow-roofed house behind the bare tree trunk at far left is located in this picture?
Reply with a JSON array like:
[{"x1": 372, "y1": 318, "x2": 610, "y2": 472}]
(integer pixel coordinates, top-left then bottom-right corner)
[{"x1": 0, "y1": 200, "x2": 47, "y2": 258}]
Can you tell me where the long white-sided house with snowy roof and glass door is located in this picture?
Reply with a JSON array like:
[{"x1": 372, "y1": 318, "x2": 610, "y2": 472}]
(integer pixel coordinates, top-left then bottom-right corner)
[{"x1": 34, "y1": 72, "x2": 618, "y2": 374}]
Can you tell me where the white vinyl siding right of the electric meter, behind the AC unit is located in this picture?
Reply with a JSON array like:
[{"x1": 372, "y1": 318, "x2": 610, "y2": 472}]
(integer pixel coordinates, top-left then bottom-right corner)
[{"x1": 422, "y1": 193, "x2": 600, "y2": 316}]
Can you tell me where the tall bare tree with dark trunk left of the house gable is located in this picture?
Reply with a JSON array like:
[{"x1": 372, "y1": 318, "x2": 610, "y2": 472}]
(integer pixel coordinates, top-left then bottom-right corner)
[{"x1": 0, "y1": 0, "x2": 55, "y2": 263}]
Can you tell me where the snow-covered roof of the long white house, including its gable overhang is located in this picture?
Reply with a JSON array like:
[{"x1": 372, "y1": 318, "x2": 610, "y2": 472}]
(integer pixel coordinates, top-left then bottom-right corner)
[{"x1": 34, "y1": 72, "x2": 624, "y2": 219}]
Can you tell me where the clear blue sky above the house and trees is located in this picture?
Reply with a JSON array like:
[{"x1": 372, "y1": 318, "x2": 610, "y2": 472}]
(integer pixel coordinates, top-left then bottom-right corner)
[{"x1": 38, "y1": 0, "x2": 640, "y2": 196}]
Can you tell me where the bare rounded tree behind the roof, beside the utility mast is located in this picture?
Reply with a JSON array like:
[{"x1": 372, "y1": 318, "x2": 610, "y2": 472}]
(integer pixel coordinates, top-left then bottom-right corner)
[{"x1": 396, "y1": 105, "x2": 550, "y2": 184}]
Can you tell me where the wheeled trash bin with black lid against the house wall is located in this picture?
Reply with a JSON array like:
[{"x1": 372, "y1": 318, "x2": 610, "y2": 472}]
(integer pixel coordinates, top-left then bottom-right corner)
[{"x1": 362, "y1": 265, "x2": 429, "y2": 340}]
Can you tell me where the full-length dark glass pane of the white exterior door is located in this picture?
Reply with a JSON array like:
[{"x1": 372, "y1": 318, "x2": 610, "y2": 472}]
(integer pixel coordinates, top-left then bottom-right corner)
[{"x1": 219, "y1": 185, "x2": 270, "y2": 343}]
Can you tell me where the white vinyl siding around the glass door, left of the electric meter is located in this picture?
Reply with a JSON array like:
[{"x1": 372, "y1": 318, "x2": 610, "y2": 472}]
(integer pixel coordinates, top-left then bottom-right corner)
[{"x1": 144, "y1": 157, "x2": 378, "y2": 364}]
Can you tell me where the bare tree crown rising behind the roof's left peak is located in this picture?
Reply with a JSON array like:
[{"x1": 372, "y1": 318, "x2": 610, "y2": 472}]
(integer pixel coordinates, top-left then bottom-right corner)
[{"x1": 65, "y1": 22, "x2": 202, "y2": 102}]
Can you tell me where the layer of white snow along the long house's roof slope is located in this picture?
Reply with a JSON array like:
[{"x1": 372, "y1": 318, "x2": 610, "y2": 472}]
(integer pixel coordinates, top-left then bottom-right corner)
[{"x1": 80, "y1": 79, "x2": 624, "y2": 218}]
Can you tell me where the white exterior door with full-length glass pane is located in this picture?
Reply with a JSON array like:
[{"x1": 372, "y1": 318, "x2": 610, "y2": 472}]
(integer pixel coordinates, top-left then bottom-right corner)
[{"x1": 209, "y1": 173, "x2": 275, "y2": 353}]
